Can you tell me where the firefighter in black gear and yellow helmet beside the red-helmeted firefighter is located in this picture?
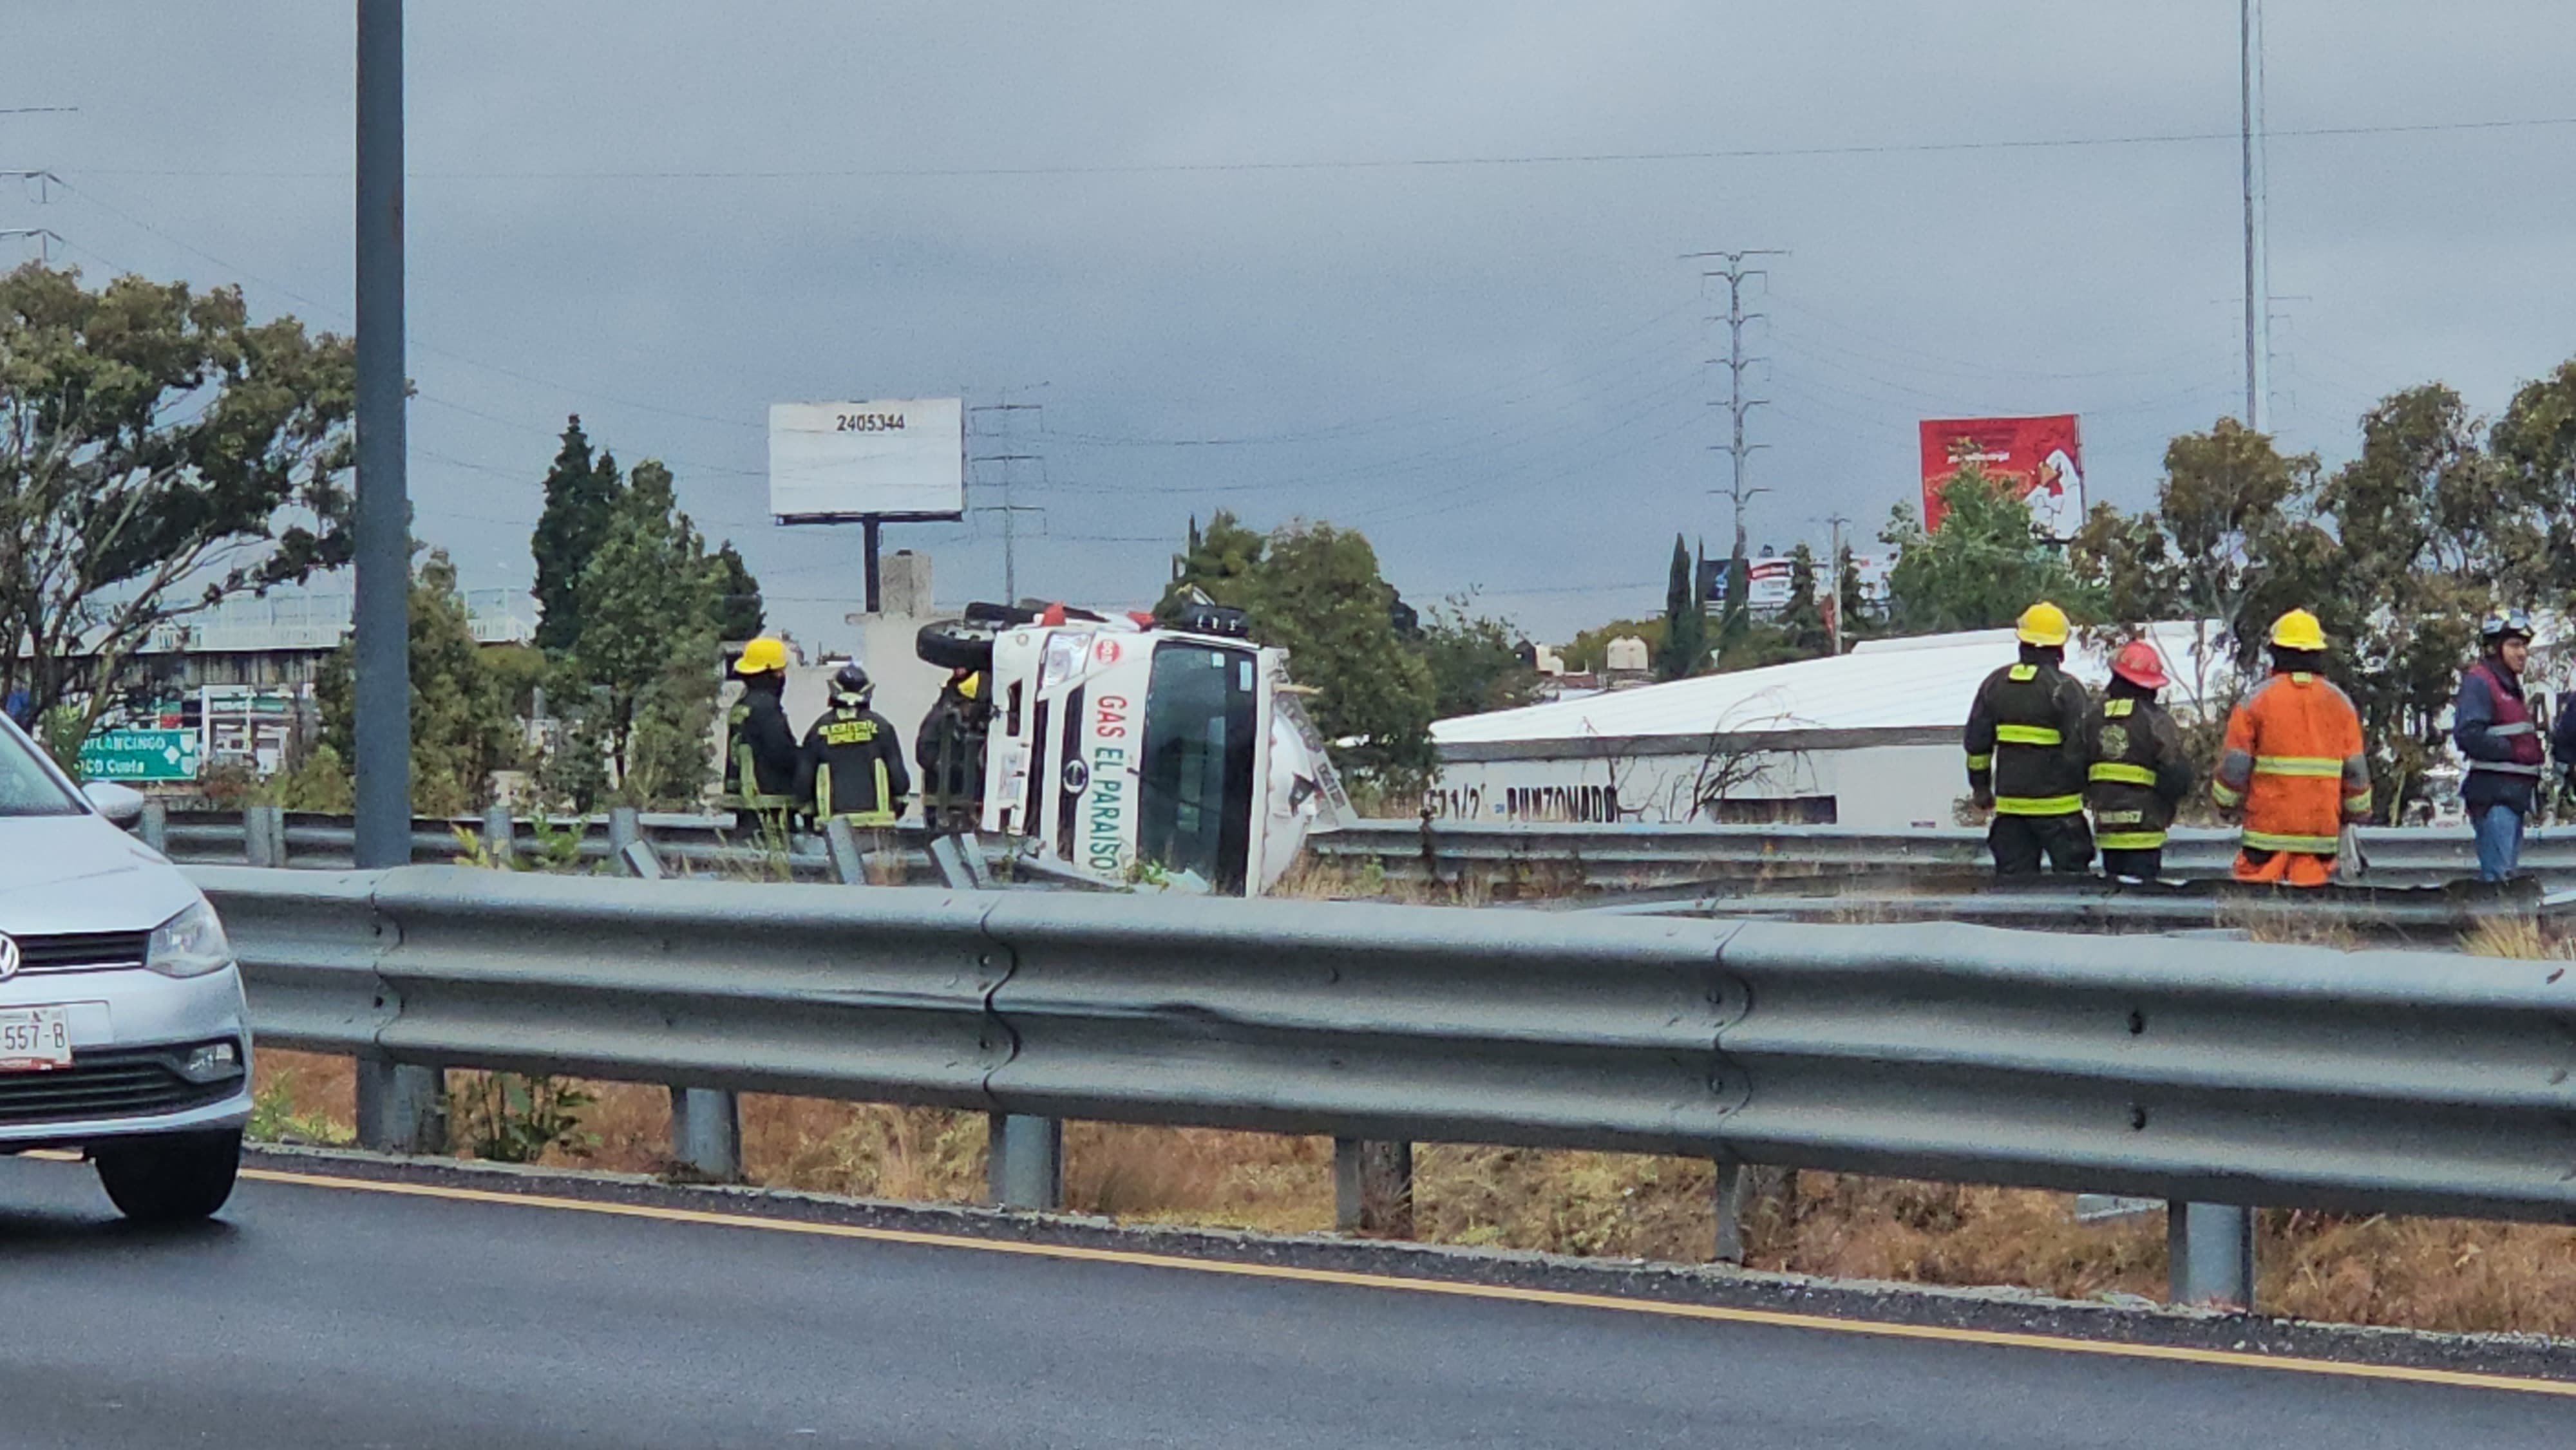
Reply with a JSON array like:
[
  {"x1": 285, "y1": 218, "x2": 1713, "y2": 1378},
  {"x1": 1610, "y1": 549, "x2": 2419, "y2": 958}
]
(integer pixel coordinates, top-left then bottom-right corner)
[{"x1": 1968, "y1": 600, "x2": 2092, "y2": 876}]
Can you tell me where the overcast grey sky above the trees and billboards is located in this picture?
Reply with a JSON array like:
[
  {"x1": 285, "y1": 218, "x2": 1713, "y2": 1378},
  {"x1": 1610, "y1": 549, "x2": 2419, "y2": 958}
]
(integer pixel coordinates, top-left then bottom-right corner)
[{"x1": 0, "y1": 0, "x2": 2576, "y2": 644}]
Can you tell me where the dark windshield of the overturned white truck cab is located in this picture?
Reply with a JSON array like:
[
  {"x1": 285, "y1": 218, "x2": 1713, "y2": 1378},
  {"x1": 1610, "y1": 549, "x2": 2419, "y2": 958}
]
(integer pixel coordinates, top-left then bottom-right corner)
[{"x1": 1136, "y1": 639, "x2": 1260, "y2": 891}]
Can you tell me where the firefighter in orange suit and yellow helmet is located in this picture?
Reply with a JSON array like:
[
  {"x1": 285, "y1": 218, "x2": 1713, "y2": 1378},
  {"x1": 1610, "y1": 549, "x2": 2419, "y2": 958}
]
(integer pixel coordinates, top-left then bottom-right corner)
[{"x1": 2210, "y1": 610, "x2": 2370, "y2": 886}]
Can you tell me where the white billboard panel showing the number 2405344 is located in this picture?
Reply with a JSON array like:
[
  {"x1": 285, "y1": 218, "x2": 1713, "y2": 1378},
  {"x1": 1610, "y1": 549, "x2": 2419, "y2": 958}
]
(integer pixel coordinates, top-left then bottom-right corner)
[{"x1": 770, "y1": 397, "x2": 966, "y2": 523}]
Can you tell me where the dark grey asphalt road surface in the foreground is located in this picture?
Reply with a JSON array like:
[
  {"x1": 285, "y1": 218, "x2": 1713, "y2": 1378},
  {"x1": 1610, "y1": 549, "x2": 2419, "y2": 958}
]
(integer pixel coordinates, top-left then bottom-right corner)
[{"x1": 0, "y1": 1159, "x2": 2576, "y2": 1450}]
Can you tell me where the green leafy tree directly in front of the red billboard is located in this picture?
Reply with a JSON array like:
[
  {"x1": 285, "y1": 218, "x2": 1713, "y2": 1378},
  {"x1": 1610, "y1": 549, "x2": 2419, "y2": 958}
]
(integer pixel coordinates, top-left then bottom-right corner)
[{"x1": 1878, "y1": 469, "x2": 2099, "y2": 634}]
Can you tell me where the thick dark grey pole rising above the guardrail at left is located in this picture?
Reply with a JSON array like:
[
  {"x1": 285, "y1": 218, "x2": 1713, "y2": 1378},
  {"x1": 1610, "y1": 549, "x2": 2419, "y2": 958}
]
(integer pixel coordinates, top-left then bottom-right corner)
[{"x1": 355, "y1": 0, "x2": 412, "y2": 871}]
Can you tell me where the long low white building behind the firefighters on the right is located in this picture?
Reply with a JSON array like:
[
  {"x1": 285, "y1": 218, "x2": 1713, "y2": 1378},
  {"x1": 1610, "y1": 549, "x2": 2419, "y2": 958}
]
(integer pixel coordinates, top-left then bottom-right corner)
[{"x1": 1430, "y1": 621, "x2": 2228, "y2": 829}]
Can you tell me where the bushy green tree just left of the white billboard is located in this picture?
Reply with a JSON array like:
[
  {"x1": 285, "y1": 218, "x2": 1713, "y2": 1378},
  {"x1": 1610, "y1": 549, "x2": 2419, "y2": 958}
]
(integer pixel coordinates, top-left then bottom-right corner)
[{"x1": 569, "y1": 458, "x2": 719, "y2": 804}]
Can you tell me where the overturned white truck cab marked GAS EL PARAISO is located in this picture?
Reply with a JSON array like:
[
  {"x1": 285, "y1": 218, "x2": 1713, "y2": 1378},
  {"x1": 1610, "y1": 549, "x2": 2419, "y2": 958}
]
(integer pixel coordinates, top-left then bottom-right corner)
[{"x1": 922, "y1": 605, "x2": 1350, "y2": 896}]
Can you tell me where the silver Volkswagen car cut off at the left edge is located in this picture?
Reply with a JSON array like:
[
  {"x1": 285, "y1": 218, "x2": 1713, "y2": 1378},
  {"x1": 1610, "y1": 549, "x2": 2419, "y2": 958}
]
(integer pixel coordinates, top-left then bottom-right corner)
[{"x1": 0, "y1": 719, "x2": 250, "y2": 1223}]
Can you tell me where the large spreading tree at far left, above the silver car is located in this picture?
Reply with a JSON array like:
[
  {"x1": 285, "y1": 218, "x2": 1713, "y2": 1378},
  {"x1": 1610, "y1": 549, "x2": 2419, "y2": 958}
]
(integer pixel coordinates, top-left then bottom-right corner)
[{"x1": 0, "y1": 263, "x2": 355, "y2": 734}]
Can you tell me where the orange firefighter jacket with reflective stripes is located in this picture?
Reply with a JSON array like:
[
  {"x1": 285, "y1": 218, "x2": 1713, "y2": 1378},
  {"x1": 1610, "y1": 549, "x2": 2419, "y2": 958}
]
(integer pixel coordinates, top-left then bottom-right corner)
[{"x1": 2210, "y1": 672, "x2": 2370, "y2": 855}]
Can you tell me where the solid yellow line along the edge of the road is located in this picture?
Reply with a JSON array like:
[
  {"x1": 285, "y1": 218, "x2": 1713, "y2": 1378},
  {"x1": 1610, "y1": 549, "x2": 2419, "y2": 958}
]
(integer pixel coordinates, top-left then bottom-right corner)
[{"x1": 227, "y1": 1167, "x2": 2576, "y2": 1398}]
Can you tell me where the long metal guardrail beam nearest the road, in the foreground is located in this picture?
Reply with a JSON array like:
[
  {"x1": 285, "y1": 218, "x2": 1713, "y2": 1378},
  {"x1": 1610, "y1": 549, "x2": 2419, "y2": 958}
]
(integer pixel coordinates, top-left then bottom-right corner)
[{"x1": 191, "y1": 868, "x2": 2576, "y2": 1221}]
